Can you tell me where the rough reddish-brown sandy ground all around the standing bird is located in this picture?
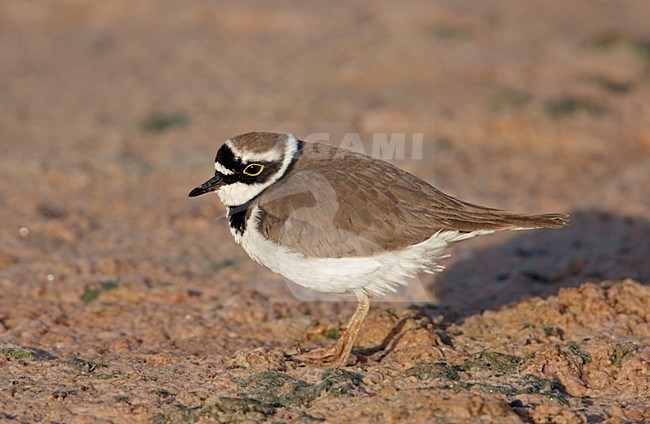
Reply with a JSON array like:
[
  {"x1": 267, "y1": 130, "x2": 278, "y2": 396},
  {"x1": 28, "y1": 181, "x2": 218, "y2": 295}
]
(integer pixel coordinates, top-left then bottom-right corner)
[{"x1": 0, "y1": 0, "x2": 650, "y2": 423}]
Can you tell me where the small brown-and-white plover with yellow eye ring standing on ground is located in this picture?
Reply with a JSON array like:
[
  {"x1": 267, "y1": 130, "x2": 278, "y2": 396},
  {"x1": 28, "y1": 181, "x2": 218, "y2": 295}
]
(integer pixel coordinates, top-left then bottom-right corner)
[{"x1": 189, "y1": 132, "x2": 568, "y2": 366}]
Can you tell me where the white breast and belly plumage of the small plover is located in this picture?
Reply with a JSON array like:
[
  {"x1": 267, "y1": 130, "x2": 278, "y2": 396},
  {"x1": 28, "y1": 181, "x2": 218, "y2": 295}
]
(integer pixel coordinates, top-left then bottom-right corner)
[{"x1": 233, "y1": 206, "x2": 492, "y2": 295}]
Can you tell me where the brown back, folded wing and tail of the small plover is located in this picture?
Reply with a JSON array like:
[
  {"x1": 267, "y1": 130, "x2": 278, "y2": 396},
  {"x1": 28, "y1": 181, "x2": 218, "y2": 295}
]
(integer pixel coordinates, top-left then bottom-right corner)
[{"x1": 256, "y1": 143, "x2": 566, "y2": 257}]
